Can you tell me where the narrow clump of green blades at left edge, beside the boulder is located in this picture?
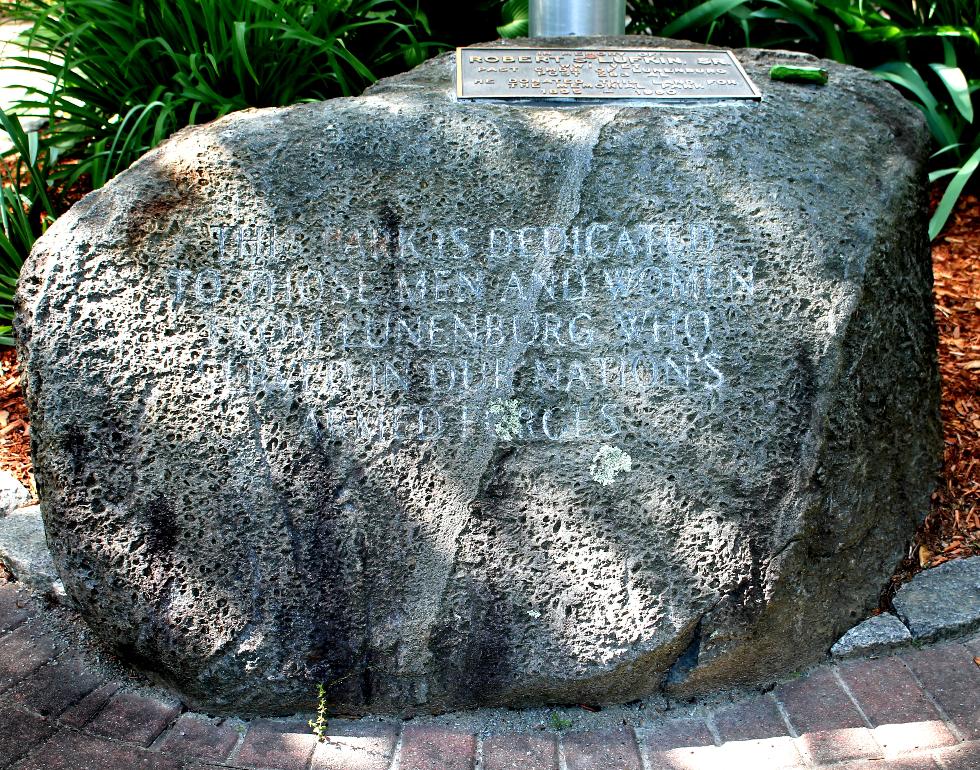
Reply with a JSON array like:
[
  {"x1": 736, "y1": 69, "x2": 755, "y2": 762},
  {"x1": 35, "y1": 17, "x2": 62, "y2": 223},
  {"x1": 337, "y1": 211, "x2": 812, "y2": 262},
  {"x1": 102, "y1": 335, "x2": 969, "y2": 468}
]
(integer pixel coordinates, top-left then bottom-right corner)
[{"x1": 0, "y1": 110, "x2": 57, "y2": 345}]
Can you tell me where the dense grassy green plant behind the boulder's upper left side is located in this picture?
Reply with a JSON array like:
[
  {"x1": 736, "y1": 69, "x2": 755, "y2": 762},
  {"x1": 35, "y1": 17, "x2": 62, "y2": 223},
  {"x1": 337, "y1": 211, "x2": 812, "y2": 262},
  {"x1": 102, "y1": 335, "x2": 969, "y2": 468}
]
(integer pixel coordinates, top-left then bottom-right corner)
[{"x1": 8, "y1": 0, "x2": 435, "y2": 192}]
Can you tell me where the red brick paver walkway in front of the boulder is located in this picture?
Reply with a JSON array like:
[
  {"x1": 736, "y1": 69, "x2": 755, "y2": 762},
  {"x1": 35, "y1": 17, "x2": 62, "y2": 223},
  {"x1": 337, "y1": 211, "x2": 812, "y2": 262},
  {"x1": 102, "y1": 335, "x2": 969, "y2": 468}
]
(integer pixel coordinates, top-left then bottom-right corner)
[{"x1": 0, "y1": 583, "x2": 980, "y2": 770}]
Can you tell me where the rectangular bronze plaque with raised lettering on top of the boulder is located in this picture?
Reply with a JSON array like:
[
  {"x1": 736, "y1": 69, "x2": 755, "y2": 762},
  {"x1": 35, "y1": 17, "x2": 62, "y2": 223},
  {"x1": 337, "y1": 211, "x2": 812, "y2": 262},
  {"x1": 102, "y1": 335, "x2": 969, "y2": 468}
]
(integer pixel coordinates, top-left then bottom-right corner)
[{"x1": 456, "y1": 48, "x2": 762, "y2": 100}]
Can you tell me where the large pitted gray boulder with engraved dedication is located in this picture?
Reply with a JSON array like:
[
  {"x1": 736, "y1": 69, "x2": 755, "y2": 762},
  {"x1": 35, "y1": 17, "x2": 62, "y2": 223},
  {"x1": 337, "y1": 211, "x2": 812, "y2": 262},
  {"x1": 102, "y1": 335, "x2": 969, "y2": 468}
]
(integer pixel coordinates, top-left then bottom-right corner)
[{"x1": 11, "y1": 38, "x2": 940, "y2": 712}]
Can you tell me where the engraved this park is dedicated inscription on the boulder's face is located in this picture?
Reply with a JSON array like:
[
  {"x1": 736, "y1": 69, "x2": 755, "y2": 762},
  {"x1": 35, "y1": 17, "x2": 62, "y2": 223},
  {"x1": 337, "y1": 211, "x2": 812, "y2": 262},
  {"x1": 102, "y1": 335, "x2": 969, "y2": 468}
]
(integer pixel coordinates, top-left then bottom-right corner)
[{"x1": 166, "y1": 222, "x2": 757, "y2": 464}]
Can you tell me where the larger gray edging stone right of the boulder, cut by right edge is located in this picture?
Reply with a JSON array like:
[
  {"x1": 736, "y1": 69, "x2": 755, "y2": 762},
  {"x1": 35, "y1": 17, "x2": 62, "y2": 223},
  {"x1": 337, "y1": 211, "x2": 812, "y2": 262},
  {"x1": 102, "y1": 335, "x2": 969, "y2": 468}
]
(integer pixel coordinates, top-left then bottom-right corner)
[{"x1": 892, "y1": 556, "x2": 980, "y2": 641}]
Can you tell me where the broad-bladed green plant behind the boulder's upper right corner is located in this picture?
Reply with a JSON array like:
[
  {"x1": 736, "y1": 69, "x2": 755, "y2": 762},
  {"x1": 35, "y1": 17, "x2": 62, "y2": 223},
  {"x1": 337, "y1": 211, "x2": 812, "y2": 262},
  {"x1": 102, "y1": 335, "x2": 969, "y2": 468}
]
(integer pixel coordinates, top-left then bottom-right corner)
[{"x1": 652, "y1": 0, "x2": 980, "y2": 238}]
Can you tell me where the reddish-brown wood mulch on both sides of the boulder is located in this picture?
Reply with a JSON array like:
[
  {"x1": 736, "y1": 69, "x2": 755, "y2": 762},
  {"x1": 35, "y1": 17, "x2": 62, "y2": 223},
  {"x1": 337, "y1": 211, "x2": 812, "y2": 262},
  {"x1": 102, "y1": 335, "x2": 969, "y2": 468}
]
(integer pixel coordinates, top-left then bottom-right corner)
[{"x1": 0, "y1": 195, "x2": 980, "y2": 588}]
